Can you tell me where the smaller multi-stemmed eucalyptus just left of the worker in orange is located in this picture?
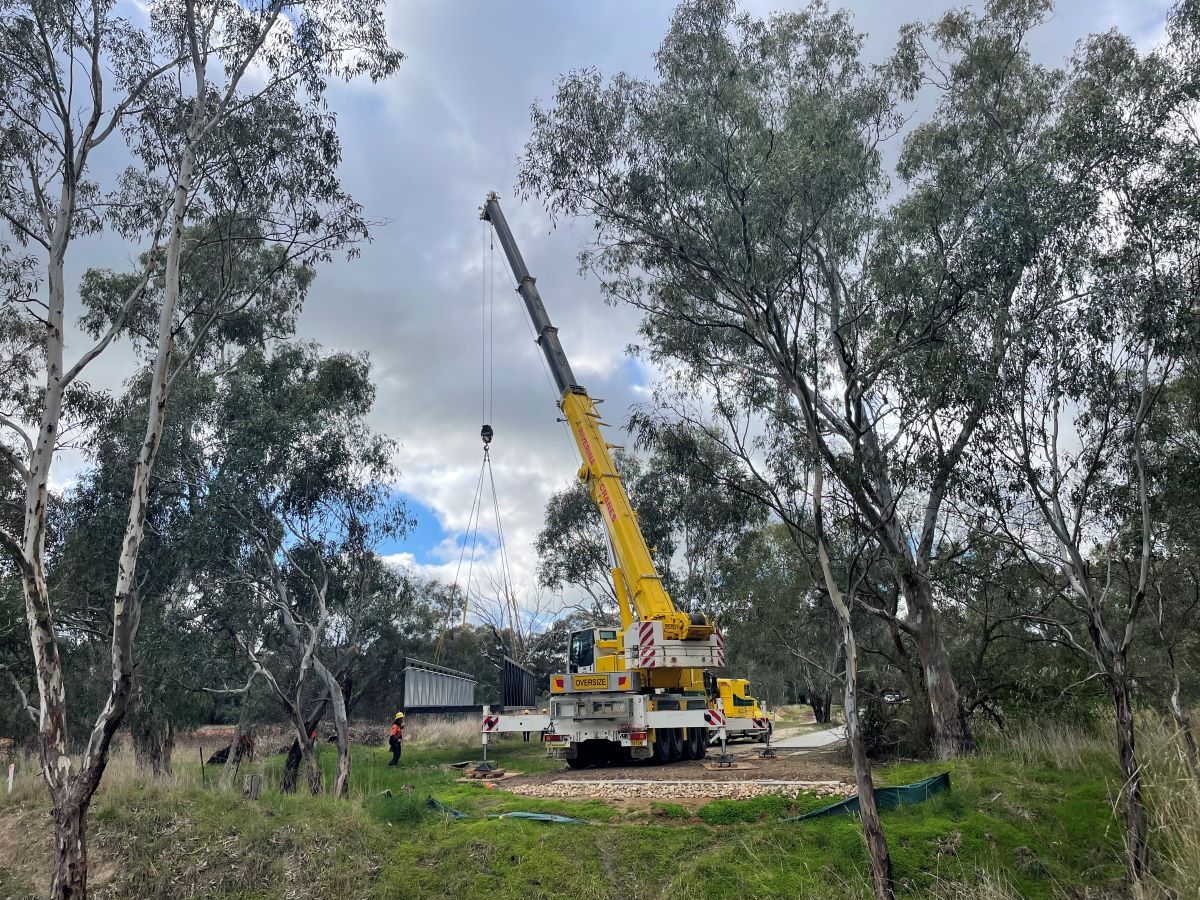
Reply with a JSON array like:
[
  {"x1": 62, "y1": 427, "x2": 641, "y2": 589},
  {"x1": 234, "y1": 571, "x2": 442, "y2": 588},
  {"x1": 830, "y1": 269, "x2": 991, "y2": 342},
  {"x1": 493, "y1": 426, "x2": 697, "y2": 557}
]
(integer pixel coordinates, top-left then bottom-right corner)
[{"x1": 199, "y1": 343, "x2": 409, "y2": 796}]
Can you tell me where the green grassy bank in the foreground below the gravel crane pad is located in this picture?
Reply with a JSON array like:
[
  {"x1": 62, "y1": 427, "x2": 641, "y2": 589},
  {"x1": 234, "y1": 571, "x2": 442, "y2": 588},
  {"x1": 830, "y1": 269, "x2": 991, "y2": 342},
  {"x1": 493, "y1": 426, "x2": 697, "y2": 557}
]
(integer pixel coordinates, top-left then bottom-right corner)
[{"x1": 0, "y1": 742, "x2": 1121, "y2": 900}]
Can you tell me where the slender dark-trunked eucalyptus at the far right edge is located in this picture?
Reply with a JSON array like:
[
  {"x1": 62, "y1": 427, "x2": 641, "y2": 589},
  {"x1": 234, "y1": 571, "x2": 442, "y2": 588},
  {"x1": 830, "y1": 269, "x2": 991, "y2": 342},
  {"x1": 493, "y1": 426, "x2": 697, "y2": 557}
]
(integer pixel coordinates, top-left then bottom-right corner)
[{"x1": 984, "y1": 7, "x2": 1200, "y2": 884}]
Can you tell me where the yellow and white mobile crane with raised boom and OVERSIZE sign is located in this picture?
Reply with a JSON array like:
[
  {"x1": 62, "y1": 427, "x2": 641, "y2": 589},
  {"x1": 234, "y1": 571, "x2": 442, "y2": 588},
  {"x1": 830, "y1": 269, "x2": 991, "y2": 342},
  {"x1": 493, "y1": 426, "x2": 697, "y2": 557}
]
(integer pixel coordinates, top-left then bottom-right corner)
[{"x1": 480, "y1": 192, "x2": 770, "y2": 768}]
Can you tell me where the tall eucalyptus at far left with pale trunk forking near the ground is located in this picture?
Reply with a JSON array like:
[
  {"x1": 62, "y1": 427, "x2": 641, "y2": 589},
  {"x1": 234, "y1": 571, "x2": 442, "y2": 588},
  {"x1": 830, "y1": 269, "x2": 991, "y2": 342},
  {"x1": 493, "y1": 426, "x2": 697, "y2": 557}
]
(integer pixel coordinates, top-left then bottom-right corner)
[{"x1": 0, "y1": 0, "x2": 401, "y2": 896}]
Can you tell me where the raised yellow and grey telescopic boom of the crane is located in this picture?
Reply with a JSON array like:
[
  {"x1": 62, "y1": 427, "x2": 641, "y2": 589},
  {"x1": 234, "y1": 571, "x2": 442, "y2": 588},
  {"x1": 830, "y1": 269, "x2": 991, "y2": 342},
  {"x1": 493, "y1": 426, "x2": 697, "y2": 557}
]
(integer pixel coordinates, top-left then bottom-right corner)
[{"x1": 481, "y1": 193, "x2": 713, "y2": 641}]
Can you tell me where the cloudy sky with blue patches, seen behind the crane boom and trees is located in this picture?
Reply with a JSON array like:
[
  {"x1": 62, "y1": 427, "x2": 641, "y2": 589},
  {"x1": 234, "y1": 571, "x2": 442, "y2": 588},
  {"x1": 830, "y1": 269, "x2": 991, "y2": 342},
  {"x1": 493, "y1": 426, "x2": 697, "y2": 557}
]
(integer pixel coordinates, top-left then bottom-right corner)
[{"x1": 59, "y1": 0, "x2": 1166, "y2": 619}]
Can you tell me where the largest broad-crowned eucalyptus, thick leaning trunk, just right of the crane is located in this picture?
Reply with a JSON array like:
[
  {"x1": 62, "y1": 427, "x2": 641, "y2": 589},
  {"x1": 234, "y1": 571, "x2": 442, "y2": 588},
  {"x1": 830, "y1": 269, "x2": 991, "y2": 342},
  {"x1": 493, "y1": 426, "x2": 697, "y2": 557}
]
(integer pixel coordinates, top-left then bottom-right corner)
[{"x1": 520, "y1": 0, "x2": 1094, "y2": 756}]
